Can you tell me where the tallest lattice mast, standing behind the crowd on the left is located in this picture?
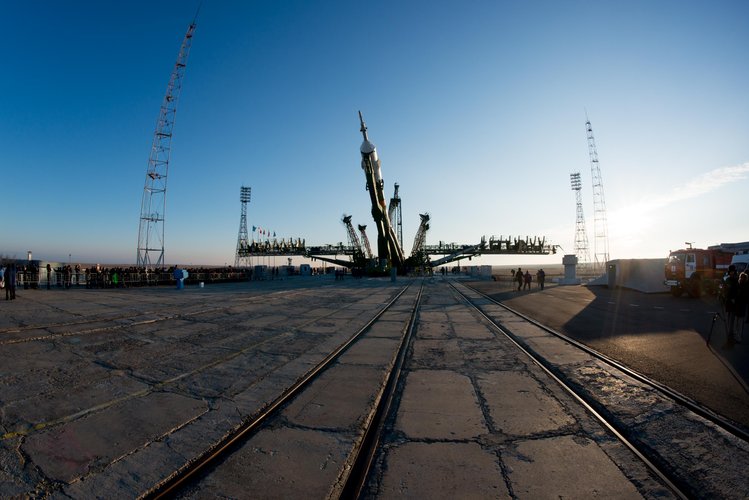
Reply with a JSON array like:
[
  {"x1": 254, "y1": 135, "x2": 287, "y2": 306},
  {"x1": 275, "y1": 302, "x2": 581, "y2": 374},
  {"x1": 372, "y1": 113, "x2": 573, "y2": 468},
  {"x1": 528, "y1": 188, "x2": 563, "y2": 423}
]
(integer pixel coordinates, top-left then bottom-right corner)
[{"x1": 137, "y1": 18, "x2": 197, "y2": 267}]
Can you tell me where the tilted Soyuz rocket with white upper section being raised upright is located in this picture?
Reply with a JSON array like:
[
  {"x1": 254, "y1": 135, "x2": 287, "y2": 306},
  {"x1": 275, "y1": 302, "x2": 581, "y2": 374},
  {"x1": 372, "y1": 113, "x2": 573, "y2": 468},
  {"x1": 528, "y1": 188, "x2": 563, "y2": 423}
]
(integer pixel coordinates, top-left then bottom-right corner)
[{"x1": 359, "y1": 111, "x2": 405, "y2": 269}]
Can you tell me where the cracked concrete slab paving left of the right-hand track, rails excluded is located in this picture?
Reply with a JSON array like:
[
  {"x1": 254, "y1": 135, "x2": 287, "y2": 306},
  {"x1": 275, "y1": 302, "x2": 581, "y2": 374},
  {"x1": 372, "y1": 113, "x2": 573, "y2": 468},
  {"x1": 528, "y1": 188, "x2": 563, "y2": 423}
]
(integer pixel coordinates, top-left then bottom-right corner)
[{"x1": 0, "y1": 278, "x2": 712, "y2": 498}]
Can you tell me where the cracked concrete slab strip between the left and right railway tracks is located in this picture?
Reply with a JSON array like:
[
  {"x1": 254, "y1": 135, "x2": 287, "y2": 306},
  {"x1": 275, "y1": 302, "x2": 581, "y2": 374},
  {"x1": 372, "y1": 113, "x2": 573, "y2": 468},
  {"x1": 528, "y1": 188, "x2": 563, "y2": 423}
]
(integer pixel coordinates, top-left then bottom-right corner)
[{"x1": 370, "y1": 284, "x2": 670, "y2": 498}]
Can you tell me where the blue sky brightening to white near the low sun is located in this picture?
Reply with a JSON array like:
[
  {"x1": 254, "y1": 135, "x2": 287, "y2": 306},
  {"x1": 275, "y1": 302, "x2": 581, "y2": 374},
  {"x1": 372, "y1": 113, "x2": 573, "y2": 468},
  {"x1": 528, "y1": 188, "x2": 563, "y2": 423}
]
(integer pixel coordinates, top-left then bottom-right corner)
[{"x1": 0, "y1": 0, "x2": 749, "y2": 265}]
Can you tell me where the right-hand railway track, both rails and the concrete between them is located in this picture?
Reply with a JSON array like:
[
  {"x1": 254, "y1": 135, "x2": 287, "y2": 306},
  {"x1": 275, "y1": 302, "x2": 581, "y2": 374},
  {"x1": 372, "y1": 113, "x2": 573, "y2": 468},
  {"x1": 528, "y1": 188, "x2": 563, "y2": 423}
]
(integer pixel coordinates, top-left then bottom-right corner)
[{"x1": 451, "y1": 282, "x2": 749, "y2": 498}]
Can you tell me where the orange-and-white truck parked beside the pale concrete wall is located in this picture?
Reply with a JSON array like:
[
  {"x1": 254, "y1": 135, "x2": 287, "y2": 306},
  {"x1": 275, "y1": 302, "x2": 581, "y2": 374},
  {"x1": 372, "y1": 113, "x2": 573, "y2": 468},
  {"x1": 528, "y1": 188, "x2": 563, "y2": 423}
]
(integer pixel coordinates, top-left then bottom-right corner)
[{"x1": 663, "y1": 248, "x2": 734, "y2": 297}]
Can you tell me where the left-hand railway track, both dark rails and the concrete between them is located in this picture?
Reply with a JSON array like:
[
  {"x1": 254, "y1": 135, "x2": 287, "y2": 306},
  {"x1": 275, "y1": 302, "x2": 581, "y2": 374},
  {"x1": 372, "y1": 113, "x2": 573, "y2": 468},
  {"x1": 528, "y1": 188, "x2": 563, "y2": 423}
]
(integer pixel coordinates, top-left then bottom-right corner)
[{"x1": 142, "y1": 285, "x2": 423, "y2": 499}]
